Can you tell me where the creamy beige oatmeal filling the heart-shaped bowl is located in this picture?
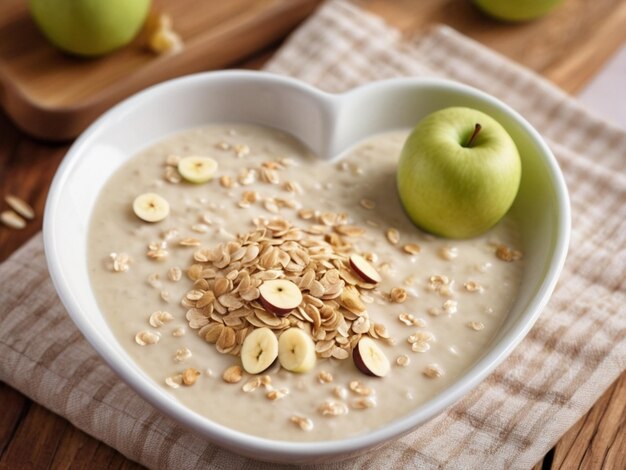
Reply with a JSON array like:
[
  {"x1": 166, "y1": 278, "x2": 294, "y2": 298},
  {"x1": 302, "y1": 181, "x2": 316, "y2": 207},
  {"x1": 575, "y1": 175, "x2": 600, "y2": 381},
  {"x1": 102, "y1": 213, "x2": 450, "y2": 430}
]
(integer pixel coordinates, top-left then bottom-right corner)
[{"x1": 88, "y1": 125, "x2": 522, "y2": 441}]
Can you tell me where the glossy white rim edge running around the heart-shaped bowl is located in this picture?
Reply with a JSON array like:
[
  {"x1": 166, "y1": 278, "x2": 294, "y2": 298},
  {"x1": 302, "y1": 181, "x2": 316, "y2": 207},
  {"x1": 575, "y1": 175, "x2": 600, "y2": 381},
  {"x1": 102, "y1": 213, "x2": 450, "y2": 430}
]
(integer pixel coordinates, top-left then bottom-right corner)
[{"x1": 43, "y1": 70, "x2": 571, "y2": 460}]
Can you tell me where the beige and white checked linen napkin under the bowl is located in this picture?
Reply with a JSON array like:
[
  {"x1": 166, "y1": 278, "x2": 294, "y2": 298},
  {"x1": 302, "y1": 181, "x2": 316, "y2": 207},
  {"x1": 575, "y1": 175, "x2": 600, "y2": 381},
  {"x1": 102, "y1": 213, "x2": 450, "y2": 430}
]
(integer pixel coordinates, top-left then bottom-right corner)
[{"x1": 0, "y1": 1, "x2": 626, "y2": 469}]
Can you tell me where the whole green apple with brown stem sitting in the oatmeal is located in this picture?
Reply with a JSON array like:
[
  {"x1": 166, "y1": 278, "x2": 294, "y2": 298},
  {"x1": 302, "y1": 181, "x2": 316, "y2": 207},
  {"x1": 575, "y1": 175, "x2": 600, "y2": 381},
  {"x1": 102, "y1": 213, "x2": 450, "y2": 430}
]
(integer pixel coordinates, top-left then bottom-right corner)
[{"x1": 397, "y1": 107, "x2": 522, "y2": 238}]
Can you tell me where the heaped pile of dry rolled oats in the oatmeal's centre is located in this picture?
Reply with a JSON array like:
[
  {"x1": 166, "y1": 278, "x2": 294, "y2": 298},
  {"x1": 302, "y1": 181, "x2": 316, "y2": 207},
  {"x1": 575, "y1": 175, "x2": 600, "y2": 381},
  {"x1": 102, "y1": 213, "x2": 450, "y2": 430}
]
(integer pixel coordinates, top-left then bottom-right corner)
[{"x1": 182, "y1": 218, "x2": 391, "y2": 360}]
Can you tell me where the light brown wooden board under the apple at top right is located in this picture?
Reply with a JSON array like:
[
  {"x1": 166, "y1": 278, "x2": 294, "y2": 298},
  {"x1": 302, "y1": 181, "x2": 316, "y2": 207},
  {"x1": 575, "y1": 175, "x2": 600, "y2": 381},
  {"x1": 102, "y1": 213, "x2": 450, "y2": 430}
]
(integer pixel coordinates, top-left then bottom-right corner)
[{"x1": 357, "y1": 0, "x2": 626, "y2": 93}]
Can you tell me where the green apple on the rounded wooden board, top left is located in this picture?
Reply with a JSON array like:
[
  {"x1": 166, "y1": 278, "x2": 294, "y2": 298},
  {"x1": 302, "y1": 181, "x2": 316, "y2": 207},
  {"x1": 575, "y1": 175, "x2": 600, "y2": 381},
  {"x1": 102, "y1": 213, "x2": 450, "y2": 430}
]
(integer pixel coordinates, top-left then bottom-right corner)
[{"x1": 29, "y1": 0, "x2": 151, "y2": 56}]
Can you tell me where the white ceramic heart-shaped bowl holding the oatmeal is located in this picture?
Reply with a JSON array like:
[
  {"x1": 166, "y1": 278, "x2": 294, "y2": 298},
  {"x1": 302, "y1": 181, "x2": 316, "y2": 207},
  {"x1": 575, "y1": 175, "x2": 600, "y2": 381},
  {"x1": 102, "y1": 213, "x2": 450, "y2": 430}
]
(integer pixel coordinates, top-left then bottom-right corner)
[{"x1": 44, "y1": 71, "x2": 570, "y2": 462}]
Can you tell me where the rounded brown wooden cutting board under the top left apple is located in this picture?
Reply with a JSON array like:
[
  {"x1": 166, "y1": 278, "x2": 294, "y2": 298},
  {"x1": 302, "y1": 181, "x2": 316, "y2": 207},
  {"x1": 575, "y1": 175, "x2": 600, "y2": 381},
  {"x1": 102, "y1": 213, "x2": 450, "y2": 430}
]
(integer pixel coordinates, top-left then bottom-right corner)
[{"x1": 0, "y1": 0, "x2": 320, "y2": 140}]
